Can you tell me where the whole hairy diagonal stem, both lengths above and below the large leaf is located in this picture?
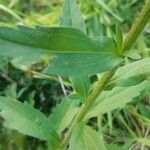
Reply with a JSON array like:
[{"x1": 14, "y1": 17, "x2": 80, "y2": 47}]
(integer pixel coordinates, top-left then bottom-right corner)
[{"x1": 62, "y1": 0, "x2": 150, "y2": 147}]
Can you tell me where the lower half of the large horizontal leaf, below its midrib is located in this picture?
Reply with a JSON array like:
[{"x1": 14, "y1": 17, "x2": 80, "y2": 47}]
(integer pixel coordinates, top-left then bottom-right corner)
[{"x1": 44, "y1": 53, "x2": 121, "y2": 76}]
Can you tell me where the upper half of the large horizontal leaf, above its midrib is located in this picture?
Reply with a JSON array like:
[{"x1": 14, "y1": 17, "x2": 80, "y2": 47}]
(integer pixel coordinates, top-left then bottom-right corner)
[{"x1": 0, "y1": 26, "x2": 115, "y2": 53}]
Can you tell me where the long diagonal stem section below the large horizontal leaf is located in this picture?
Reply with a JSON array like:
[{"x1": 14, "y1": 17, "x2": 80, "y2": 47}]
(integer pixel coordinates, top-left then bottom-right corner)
[{"x1": 63, "y1": 68, "x2": 116, "y2": 146}]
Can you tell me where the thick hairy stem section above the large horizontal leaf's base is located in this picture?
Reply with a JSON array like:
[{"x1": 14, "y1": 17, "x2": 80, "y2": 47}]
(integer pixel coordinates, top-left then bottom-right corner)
[{"x1": 121, "y1": 0, "x2": 150, "y2": 53}]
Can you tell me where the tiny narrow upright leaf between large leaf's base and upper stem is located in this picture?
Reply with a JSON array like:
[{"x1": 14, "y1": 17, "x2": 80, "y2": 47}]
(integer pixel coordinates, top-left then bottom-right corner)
[{"x1": 116, "y1": 24, "x2": 123, "y2": 52}]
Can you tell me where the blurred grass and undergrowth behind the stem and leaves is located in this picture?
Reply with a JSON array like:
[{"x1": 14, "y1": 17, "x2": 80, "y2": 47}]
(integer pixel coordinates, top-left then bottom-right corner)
[{"x1": 0, "y1": 0, "x2": 150, "y2": 150}]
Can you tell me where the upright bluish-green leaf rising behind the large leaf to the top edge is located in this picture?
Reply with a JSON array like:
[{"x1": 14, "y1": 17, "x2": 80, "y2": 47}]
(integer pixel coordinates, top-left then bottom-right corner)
[{"x1": 60, "y1": 0, "x2": 86, "y2": 33}]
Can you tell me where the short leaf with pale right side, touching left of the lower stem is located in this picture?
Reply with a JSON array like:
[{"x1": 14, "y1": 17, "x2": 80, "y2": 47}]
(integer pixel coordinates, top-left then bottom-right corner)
[{"x1": 49, "y1": 95, "x2": 80, "y2": 134}]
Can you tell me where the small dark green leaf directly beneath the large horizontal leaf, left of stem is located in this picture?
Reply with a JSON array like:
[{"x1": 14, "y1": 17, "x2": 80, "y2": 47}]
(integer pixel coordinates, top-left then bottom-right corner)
[{"x1": 70, "y1": 76, "x2": 90, "y2": 100}]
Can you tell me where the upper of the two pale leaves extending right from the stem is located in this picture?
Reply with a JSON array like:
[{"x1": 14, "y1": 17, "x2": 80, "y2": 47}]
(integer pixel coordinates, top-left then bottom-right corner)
[{"x1": 109, "y1": 58, "x2": 150, "y2": 85}]
